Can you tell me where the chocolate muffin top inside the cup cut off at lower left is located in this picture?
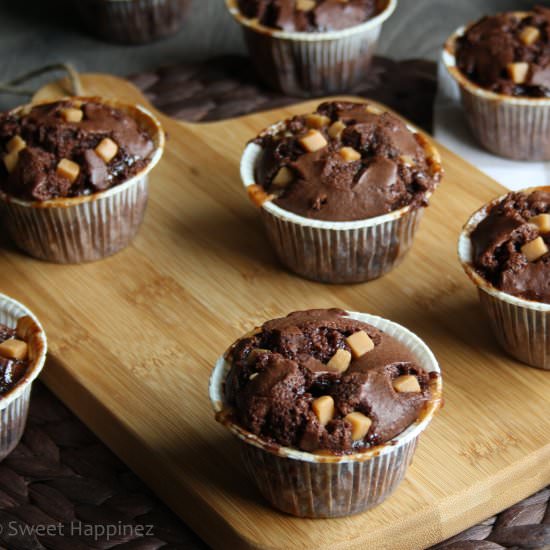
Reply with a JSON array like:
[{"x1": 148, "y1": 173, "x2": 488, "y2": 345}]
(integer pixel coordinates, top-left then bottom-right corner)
[{"x1": 0, "y1": 317, "x2": 33, "y2": 396}]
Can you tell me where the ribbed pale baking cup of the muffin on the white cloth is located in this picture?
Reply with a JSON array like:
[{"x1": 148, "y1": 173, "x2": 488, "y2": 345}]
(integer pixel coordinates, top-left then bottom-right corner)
[{"x1": 442, "y1": 17, "x2": 550, "y2": 160}]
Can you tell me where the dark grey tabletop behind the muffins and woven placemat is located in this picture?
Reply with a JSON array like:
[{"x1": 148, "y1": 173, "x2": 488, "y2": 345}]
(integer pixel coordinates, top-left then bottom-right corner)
[{"x1": 0, "y1": 0, "x2": 548, "y2": 108}]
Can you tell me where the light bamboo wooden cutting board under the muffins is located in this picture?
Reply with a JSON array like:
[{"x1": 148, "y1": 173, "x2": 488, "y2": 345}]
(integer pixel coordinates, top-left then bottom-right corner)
[{"x1": 0, "y1": 75, "x2": 550, "y2": 550}]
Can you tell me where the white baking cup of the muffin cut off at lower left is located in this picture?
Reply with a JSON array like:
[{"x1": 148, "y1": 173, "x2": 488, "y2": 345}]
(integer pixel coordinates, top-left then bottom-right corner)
[{"x1": 0, "y1": 294, "x2": 48, "y2": 460}]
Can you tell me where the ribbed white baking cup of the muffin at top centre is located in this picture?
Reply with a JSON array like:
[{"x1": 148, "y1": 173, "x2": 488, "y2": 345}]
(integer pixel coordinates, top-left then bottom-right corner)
[{"x1": 226, "y1": 0, "x2": 397, "y2": 97}]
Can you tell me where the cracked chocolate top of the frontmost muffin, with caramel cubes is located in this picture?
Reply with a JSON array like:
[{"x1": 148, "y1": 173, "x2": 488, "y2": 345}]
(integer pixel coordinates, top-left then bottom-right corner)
[{"x1": 225, "y1": 309, "x2": 431, "y2": 454}]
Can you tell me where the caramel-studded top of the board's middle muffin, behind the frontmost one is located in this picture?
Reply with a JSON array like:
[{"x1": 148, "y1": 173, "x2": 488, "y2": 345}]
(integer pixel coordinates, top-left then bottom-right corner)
[{"x1": 249, "y1": 102, "x2": 440, "y2": 221}]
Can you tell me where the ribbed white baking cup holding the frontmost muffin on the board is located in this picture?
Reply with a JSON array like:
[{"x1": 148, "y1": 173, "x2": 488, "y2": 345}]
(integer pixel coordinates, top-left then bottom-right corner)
[{"x1": 209, "y1": 312, "x2": 443, "y2": 518}]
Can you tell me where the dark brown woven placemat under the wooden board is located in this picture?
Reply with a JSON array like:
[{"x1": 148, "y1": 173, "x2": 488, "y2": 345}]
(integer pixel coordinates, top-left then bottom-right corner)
[{"x1": 0, "y1": 57, "x2": 550, "y2": 550}]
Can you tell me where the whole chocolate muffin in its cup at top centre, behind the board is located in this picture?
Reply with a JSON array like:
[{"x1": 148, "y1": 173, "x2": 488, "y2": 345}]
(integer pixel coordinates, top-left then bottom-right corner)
[{"x1": 226, "y1": 0, "x2": 396, "y2": 97}]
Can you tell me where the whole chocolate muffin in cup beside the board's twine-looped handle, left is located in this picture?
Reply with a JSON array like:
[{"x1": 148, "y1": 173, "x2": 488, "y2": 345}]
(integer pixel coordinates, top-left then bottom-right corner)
[{"x1": 0, "y1": 97, "x2": 164, "y2": 263}]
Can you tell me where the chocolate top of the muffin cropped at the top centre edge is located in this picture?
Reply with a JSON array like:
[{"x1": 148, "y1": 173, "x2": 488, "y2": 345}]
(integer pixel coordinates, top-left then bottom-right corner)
[{"x1": 238, "y1": 0, "x2": 378, "y2": 32}]
